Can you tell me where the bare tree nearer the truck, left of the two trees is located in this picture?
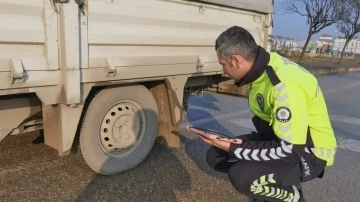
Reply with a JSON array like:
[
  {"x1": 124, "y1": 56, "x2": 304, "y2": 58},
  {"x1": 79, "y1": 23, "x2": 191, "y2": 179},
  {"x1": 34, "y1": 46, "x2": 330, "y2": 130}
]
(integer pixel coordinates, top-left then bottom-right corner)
[{"x1": 282, "y1": 0, "x2": 344, "y2": 63}]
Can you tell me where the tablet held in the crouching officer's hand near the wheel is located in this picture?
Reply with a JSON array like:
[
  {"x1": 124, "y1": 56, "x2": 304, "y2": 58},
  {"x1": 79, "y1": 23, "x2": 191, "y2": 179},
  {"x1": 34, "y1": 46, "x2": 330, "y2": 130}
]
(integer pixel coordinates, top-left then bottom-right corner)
[{"x1": 186, "y1": 126, "x2": 242, "y2": 144}]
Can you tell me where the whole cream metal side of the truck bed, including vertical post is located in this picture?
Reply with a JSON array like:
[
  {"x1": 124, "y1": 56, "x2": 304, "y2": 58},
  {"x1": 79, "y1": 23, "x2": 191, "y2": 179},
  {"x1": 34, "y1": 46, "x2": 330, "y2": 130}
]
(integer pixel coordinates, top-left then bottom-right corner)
[{"x1": 0, "y1": 0, "x2": 271, "y2": 101}]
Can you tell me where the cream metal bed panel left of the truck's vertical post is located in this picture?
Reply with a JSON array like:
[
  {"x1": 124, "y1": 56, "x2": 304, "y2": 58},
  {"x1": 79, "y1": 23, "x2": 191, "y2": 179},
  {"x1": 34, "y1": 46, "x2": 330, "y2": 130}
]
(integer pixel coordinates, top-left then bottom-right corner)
[{"x1": 0, "y1": 0, "x2": 58, "y2": 72}]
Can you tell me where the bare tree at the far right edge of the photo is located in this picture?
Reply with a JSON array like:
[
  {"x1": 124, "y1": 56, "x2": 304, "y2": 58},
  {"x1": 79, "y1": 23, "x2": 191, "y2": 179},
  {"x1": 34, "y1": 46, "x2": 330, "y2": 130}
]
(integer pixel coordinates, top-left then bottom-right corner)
[{"x1": 337, "y1": 0, "x2": 360, "y2": 63}]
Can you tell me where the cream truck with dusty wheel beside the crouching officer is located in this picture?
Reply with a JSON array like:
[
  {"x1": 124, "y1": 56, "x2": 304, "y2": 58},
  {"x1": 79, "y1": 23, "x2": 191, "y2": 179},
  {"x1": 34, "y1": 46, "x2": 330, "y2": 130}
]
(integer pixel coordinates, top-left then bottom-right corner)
[{"x1": 0, "y1": 0, "x2": 274, "y2": 175}]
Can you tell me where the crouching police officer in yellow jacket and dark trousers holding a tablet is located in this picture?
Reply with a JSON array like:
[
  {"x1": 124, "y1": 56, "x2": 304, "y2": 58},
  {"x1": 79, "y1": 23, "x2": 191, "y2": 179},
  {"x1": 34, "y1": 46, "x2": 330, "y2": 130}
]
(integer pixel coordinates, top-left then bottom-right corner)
[{"x1": 203, "y1": 26, "x2": 337, "y2": 202}]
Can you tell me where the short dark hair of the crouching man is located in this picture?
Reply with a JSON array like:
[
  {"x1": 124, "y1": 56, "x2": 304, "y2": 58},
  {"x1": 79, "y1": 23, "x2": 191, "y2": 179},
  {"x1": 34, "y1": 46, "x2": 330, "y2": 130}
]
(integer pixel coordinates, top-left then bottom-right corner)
[{"x1": 215, "y1": 26, "x2": 258, "y2": 61}]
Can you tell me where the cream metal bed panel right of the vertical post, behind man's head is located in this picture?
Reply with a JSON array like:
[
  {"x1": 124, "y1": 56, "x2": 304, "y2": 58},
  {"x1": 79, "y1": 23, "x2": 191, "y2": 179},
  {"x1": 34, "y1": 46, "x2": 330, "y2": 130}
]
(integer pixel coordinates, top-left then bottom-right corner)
[{"x1": 84, "y1": 0, "x2": 264, "y2": 76}]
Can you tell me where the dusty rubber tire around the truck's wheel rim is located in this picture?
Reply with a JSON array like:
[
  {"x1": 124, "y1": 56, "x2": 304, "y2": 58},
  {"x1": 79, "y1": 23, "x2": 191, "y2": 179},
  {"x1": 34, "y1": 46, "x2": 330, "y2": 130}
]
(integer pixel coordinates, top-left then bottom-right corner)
[{"x1": 80, "y1": 86, "x2": 158, "y2": 175}]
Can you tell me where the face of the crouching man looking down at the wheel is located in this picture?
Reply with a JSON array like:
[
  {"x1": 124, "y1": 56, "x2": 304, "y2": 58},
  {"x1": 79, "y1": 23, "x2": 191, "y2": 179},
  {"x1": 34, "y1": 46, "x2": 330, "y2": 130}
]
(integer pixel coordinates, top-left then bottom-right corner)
[{"x1": 217, "y1": 52, "x2": 245, "y2": 81}]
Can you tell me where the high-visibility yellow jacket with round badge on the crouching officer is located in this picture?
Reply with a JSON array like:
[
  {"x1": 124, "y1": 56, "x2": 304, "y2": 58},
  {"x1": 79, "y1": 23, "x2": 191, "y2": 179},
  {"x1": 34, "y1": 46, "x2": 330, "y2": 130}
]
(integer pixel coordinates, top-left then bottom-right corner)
[{"x1": 248, "y1": 53, "x2": 337, "y2": 166}]
